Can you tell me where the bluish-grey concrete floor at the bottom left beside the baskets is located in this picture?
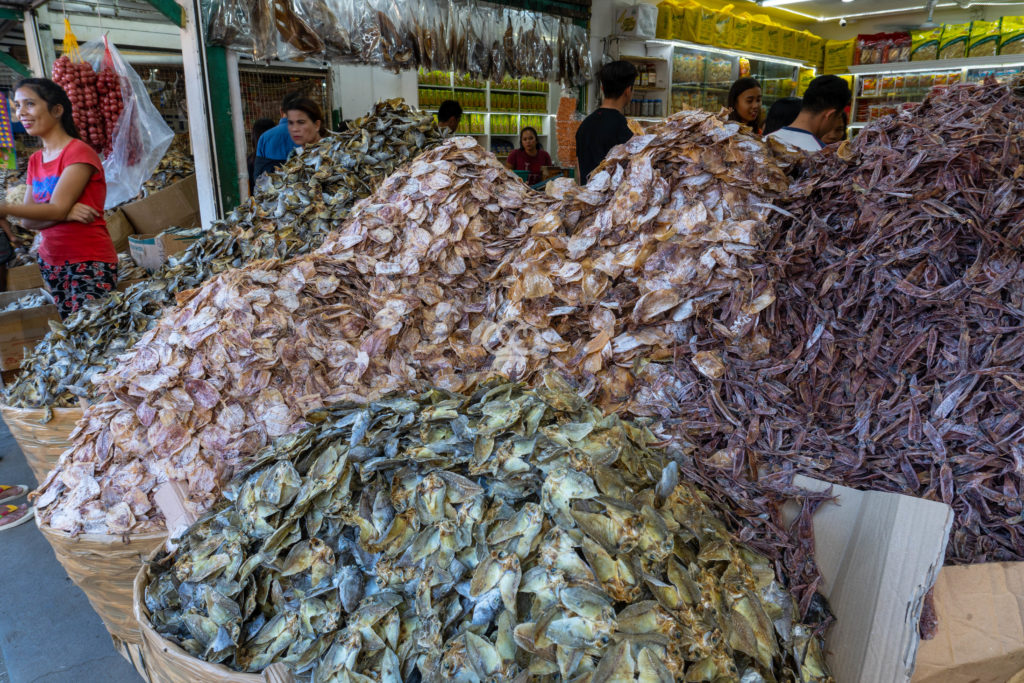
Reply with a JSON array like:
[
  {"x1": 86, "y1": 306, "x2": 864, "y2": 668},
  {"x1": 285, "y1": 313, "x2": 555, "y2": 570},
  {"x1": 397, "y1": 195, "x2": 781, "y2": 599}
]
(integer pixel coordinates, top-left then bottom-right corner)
[{"x1": 0, "y1": 421, "x2": 141, "y2": 683}]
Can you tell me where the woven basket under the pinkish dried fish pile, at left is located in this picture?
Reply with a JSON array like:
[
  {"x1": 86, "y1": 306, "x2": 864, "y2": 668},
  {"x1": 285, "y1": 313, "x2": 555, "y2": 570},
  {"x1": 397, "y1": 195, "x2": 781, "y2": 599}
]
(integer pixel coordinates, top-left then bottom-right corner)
[{"x1": 39, "y1": 524, "x2": 167, "y2": 643}]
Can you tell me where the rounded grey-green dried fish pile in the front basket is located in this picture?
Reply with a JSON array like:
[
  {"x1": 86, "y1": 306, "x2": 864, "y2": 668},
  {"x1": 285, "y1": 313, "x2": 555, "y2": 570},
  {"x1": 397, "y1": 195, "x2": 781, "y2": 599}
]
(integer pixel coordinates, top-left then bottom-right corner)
[{"x1": 144, "y1": 376, "x2": 833, "y2": 683}]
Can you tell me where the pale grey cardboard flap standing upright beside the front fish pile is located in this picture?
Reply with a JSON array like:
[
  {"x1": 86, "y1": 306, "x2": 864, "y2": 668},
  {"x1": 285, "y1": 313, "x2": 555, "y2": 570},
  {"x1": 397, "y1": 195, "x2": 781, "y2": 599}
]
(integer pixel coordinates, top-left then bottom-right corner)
[{"x1": 790, "y1": 476, "x2": 953, "y2": 683}]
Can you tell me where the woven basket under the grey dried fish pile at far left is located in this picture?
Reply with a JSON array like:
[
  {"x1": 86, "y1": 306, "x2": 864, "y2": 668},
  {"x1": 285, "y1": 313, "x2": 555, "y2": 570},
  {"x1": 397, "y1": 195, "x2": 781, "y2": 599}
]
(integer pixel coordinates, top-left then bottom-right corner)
[{"x1": 0, "y1": 405, "x2": 82, "y2": 483}]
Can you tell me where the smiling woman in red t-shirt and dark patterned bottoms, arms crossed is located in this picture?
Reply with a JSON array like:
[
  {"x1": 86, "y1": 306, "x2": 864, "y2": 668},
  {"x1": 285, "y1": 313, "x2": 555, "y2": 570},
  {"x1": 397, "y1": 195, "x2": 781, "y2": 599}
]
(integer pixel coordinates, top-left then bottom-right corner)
[{"x1": 0, "y1": 78, "x2": 118, "y2": 318}]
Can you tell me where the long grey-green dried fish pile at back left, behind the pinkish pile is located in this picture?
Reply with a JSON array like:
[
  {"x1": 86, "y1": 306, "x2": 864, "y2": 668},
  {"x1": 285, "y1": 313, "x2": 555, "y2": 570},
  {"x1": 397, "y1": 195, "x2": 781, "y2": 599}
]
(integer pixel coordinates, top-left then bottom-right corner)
[{"x1": 6, "y1": 100, "x2": 441, "y2": 408}]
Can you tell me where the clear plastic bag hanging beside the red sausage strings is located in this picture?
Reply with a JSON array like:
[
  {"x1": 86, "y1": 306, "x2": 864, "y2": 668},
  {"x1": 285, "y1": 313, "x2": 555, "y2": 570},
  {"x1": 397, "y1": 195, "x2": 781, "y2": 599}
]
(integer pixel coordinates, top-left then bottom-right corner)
[{"x1": 81, "y1": 38, "x2": 174, "y2": 209}]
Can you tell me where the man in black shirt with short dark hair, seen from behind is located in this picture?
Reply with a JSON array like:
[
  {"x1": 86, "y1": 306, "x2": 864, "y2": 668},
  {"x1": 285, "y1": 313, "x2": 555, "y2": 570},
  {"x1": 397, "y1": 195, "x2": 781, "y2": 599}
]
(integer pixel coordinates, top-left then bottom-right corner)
[{"x1": 577, "y1": 60, "x2": 637, "y2": 184}]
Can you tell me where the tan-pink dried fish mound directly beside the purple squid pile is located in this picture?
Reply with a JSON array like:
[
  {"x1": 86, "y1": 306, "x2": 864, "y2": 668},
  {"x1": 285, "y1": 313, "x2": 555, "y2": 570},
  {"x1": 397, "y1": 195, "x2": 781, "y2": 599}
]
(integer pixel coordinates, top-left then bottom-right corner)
[{"x1": 478, "y1": 112, "x2": 794, "y2": 405}]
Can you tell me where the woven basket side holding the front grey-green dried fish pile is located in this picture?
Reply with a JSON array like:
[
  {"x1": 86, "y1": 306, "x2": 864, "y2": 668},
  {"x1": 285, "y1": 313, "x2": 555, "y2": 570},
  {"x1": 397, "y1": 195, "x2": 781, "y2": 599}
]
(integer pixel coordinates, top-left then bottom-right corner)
[{"x1": 132, "y1": 564, "x2": 295, "y2": 683}]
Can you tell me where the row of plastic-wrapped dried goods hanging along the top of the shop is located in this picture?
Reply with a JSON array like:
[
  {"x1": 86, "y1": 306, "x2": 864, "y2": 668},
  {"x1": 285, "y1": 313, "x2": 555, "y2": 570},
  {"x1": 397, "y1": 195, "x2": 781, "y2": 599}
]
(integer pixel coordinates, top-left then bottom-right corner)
[{"x1": 203, "y1": 0, "x2": 591, "y2": 85}]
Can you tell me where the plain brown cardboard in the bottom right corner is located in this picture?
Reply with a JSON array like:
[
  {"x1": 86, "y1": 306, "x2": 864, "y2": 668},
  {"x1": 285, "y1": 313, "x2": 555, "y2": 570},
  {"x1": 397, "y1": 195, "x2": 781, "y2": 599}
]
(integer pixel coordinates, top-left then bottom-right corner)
[{"x1": 912, "y1": 562, "x2": 1024, "y2": 683}]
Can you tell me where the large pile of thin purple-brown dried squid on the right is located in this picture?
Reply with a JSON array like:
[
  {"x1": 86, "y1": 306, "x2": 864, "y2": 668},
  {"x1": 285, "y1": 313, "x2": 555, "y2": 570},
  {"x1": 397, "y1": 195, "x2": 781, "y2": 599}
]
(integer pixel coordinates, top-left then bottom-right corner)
[{"x1": 639, "y1": 82, "x2": 1024, "y2": 563}]
